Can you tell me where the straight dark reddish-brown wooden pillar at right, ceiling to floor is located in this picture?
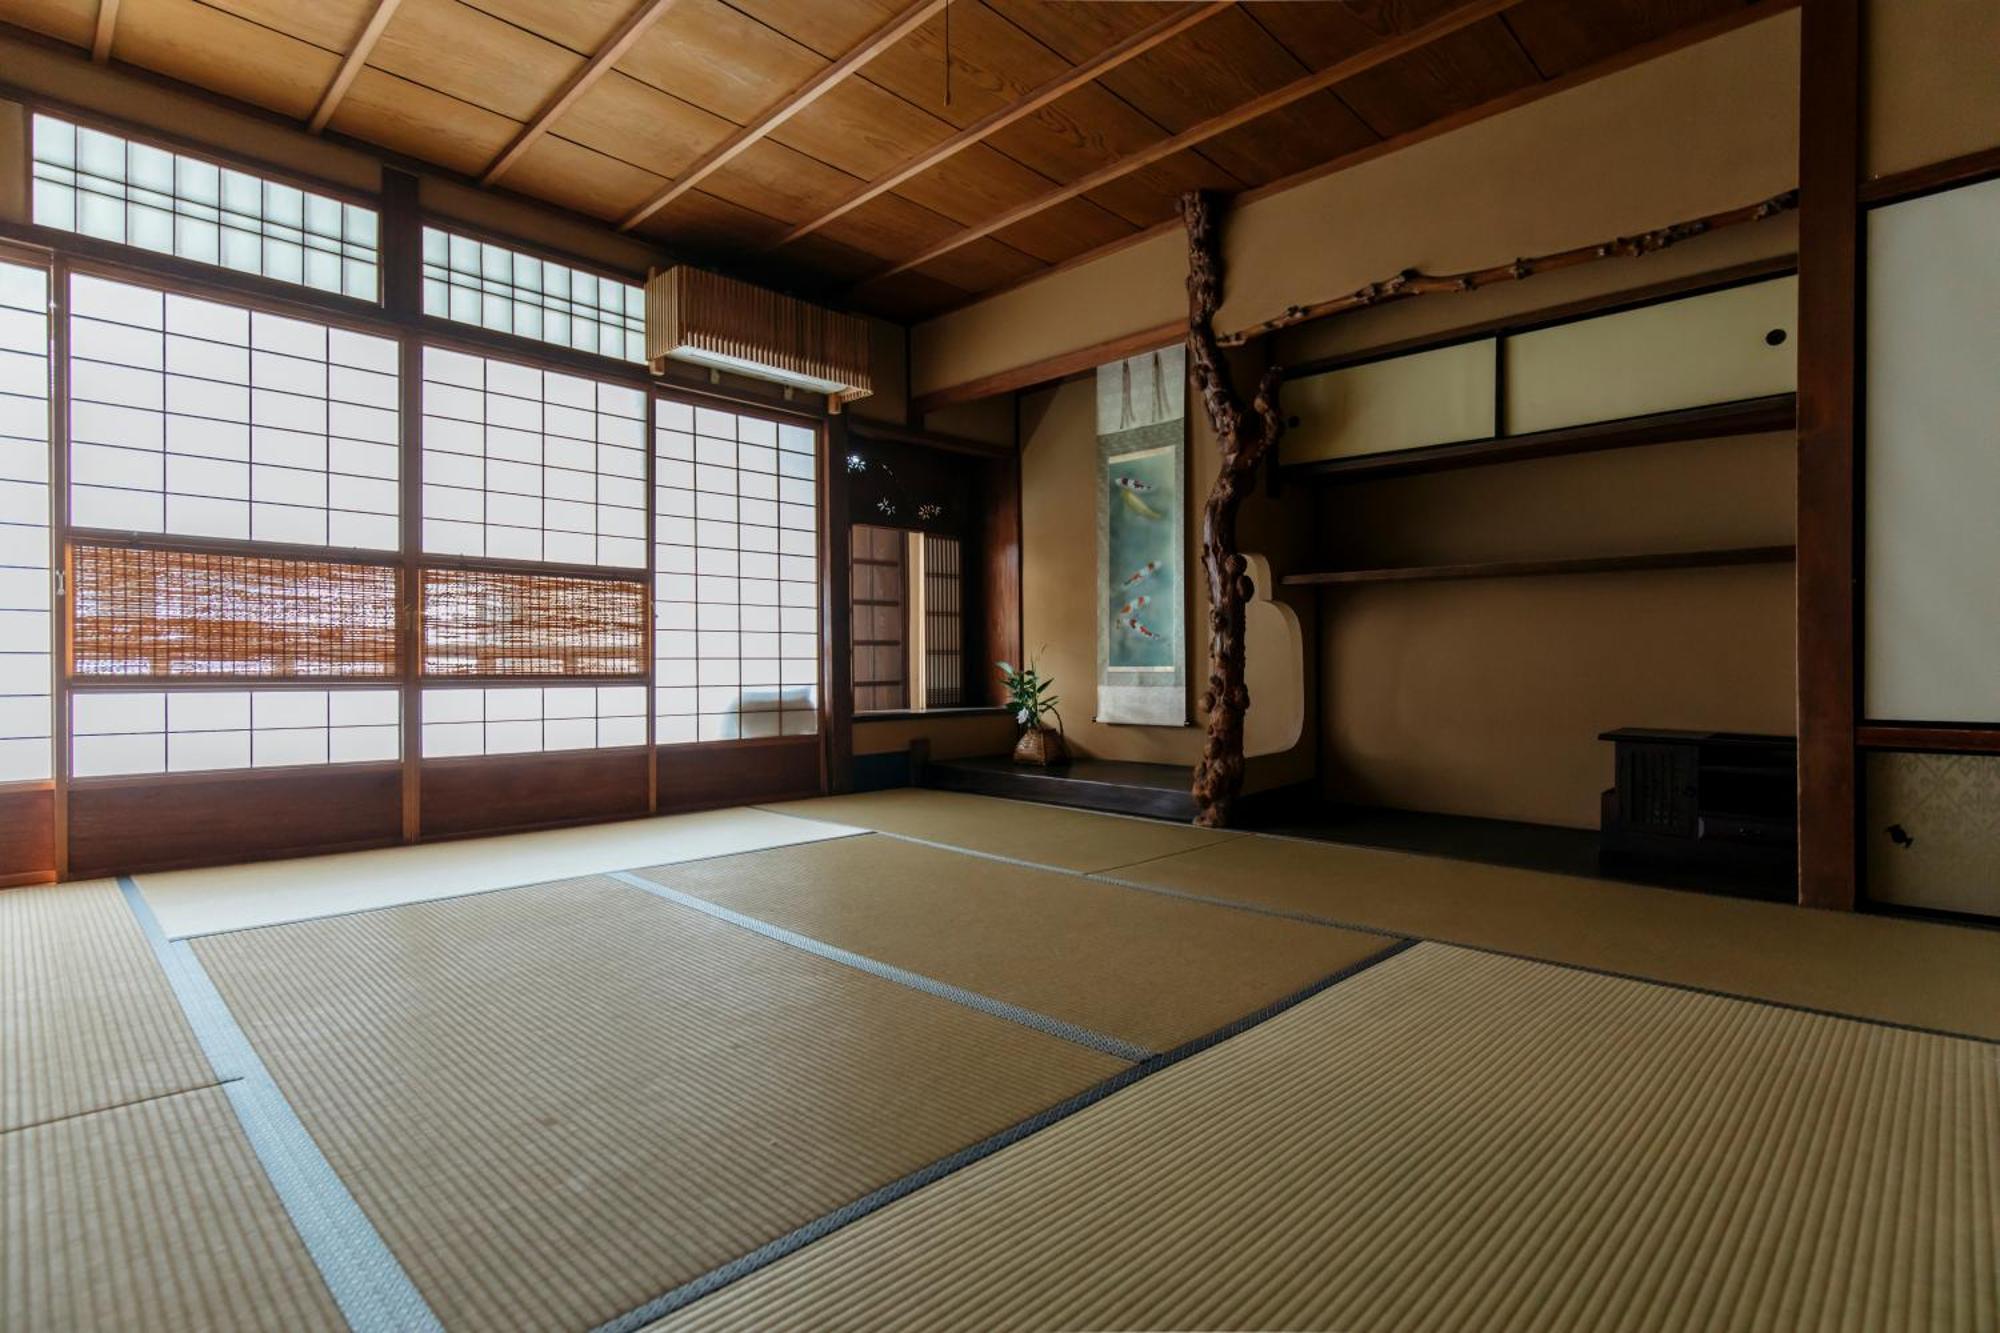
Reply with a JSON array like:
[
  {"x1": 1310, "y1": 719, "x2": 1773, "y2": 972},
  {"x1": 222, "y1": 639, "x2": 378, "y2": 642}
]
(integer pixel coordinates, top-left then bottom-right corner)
[{"x1": 1798, "y1": 0, "x2": 1862, "y2": 911}]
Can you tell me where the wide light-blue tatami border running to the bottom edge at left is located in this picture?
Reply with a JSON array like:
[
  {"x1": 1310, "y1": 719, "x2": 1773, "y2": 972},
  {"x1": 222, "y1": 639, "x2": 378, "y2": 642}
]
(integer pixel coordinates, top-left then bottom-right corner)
[{"x1": 118, "y1": 875, "x2": 442, "y2": 1333}]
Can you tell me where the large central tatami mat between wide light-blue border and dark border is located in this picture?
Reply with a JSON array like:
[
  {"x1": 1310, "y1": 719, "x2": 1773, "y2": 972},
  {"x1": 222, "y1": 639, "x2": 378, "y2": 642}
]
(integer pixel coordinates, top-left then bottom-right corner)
[{"x1": 194, "y1": 879, "x2": 1128, "y2": 1329}]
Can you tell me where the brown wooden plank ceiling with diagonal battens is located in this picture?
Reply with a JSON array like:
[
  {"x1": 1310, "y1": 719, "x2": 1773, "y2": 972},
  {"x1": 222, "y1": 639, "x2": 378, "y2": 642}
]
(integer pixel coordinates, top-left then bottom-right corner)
[{"x1": 0, "y1": 0, "x2": 1746, "y2": 320}]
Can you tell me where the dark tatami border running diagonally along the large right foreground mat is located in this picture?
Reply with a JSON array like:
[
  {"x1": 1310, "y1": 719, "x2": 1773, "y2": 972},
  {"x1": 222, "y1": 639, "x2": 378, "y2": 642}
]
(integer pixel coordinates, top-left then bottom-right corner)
[{"x1": 592, "y1": 932, "x2": 1422, "y2": 1333}]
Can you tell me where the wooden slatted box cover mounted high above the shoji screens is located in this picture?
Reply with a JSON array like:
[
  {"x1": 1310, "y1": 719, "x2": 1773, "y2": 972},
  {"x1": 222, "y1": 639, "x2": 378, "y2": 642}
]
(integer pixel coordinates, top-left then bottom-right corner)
[{"x1": 646, "y1": 264, "x2": 874, "y2": 402}]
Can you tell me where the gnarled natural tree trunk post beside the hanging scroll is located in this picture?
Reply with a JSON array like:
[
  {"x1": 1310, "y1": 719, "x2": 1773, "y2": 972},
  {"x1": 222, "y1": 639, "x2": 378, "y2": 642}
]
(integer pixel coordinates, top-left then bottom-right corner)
[{"x1": 1180, "y1": 190, "x2": 1284, "y2": 829}]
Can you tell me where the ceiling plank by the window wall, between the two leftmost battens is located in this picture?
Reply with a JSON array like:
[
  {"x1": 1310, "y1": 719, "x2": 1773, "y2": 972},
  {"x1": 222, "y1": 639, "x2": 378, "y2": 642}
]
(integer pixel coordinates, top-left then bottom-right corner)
[{"x1": 118, "y1": 0, "x2": 340, "y2": 120}]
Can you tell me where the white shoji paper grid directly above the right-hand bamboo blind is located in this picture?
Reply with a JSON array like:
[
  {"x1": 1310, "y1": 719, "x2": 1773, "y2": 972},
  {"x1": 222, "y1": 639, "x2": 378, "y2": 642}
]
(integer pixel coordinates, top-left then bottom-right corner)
[{"x1": 424, "y1": 346, "x2": 646, "y2": 568}]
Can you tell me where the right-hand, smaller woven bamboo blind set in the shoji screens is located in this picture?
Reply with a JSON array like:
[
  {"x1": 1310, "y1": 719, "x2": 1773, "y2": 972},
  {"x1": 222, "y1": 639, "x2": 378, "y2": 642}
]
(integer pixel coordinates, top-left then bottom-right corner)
[{"x1": 422, "y1": 568, "x2": 646, "y2": 679}]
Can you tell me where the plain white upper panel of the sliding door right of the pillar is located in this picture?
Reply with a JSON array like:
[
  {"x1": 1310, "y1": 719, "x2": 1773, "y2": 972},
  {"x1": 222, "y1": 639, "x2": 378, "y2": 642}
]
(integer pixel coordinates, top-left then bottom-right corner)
[{"x1": 1862, "y1": 180, "x2": 2000, "y2": 723}]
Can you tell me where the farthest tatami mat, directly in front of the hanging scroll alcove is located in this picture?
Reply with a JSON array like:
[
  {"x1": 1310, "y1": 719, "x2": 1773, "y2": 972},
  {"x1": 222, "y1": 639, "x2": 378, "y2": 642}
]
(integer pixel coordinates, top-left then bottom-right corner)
[{"x1": 756, "y1": 787, "x2": 1244, "y2": 873}]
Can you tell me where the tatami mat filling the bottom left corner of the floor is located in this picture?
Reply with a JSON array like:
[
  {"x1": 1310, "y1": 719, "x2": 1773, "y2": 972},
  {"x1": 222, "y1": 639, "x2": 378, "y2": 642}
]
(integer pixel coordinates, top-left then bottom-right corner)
[{"x1": 0, "y1": 1087, "x2": 346, "y2": 1333}]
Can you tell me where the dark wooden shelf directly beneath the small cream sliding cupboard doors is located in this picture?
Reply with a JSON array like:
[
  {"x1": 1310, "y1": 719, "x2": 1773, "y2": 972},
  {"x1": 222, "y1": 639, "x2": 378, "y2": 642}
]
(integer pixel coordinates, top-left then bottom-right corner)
[{"x1": 1280, "y1": 394, "x2": 1798, "y2": 482}]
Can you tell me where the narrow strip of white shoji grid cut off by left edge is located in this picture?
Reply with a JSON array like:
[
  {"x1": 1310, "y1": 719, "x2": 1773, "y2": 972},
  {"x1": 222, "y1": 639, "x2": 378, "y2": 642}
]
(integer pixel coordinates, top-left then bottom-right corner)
[{"x1": 0, "y1": 262, "x2": 54, "y2": 783}]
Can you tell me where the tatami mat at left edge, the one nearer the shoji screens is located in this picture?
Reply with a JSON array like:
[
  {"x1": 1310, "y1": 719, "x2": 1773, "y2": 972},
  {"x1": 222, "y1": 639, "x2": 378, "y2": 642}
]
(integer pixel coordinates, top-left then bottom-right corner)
[{"x1": 0, "y1": 879, "x2": 216, "y2": 1131}]
